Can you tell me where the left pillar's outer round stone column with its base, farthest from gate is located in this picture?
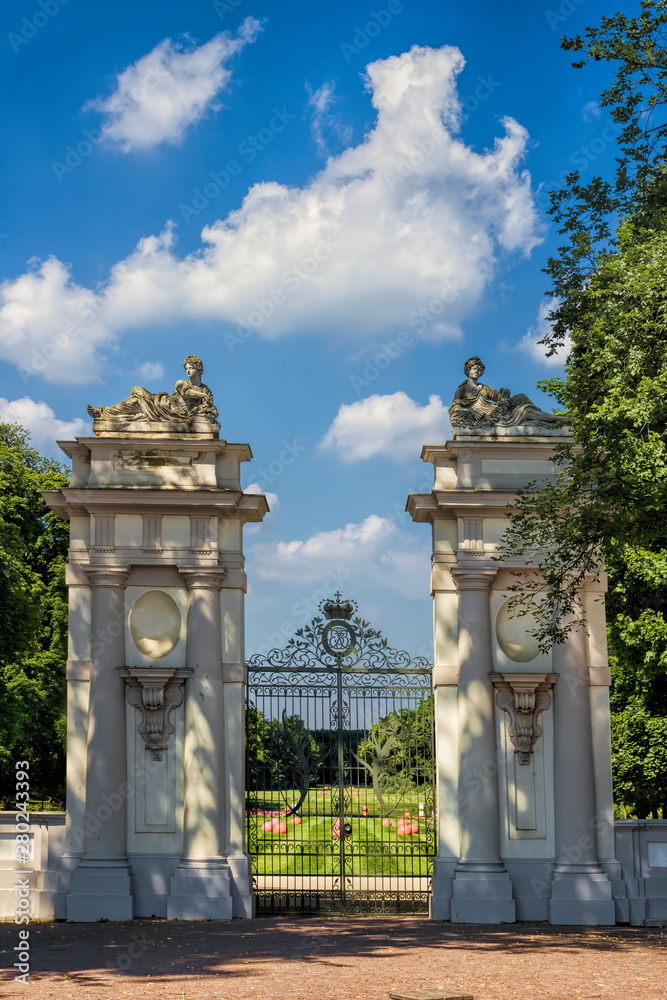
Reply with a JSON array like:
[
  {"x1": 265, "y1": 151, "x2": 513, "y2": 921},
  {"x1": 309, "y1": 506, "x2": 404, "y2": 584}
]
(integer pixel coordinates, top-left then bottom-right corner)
[{"x1": 67, "y1": 566, "x2": 133, "y2": 921}]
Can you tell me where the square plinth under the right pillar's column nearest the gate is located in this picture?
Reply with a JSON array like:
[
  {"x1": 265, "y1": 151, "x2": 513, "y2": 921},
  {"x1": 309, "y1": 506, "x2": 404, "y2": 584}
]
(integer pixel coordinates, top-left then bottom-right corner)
[{"x1": 451, "y1": 862, "x2": 516, "y2": 924}]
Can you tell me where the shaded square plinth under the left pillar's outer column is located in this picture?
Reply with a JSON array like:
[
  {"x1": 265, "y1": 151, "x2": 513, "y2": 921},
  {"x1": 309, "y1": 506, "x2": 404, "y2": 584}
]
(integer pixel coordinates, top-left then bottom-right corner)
[{"x1": 67, "y1": 859, "x2": 134, "y2": 923}]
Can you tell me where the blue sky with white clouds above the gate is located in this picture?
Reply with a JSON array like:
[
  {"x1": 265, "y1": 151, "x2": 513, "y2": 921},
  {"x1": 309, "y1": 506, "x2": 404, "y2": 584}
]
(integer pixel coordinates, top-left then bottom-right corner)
[{"x1": 0, "y1": 0, "x2": 624, "y2": 655}]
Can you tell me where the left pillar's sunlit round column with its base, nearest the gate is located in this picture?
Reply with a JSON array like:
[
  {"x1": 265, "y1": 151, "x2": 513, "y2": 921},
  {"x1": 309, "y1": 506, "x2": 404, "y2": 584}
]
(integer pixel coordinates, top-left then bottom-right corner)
[{"x1": 167, "y1": 567, "x2": 232, "y2": 920}]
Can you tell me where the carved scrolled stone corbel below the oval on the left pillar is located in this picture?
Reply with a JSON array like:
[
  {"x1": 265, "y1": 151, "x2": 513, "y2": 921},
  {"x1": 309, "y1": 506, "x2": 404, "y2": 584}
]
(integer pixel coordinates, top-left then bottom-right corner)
[{"x1": 122, "y1": 667, "x2": 192, "y2": 760}]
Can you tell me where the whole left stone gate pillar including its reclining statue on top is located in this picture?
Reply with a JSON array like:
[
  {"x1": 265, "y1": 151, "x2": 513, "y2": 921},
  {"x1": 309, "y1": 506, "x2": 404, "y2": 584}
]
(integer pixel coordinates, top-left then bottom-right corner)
[{"x1": 44, "y1": 357, "x2": 268, "y2": 921}]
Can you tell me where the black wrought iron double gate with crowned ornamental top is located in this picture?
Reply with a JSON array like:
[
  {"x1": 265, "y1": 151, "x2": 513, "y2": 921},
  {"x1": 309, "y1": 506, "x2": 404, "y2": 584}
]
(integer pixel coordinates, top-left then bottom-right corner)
[{"x1": 246, "y1": 594, "x2": 435, "y2": 914}]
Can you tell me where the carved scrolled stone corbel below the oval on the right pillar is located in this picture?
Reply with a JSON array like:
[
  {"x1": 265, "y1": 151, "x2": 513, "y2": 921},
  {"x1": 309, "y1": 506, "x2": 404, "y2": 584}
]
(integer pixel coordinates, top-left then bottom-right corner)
[{"x1": 490, "y1": 673, "x2": 558, "y2": 764}]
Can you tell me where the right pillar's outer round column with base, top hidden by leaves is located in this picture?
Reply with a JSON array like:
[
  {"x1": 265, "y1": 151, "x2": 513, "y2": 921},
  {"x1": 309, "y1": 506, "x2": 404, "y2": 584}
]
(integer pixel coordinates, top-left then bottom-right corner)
[{"x1": 549, "y1": 628, "x2": 615, "y2": 925}]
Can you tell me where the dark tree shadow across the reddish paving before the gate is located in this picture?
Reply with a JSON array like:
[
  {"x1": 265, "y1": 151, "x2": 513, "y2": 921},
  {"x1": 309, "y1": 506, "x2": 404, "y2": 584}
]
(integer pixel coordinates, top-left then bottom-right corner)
[{"x1": 0, "y1": 917, "x2": 666, "y2": 987}]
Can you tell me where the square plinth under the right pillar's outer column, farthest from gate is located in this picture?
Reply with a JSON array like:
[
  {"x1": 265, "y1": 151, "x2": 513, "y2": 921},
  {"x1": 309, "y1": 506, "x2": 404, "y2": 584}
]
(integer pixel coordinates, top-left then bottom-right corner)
[{"x1": 549, "y1": 864, "x2": 616, "y2": 927}]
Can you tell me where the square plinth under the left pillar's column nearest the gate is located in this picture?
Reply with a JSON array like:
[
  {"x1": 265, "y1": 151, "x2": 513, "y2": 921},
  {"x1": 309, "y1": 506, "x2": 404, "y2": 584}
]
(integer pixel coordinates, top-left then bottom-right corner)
[{"x1": 167, "y1": 860, "x2": 234, "y2": 920}]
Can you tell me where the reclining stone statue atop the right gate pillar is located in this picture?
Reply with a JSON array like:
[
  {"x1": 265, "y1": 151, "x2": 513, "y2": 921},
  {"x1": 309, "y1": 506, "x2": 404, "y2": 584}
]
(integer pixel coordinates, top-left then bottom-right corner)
[{"x1": 449, "y1": 357, "x2": 562, "y2": 430}]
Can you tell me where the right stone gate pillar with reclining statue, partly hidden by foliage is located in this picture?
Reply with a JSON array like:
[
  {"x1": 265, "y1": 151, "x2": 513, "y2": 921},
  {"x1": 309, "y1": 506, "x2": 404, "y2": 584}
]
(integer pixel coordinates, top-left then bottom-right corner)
[{"x1": 408, "y1": 358, "x2": 627, "y2": 924}]
